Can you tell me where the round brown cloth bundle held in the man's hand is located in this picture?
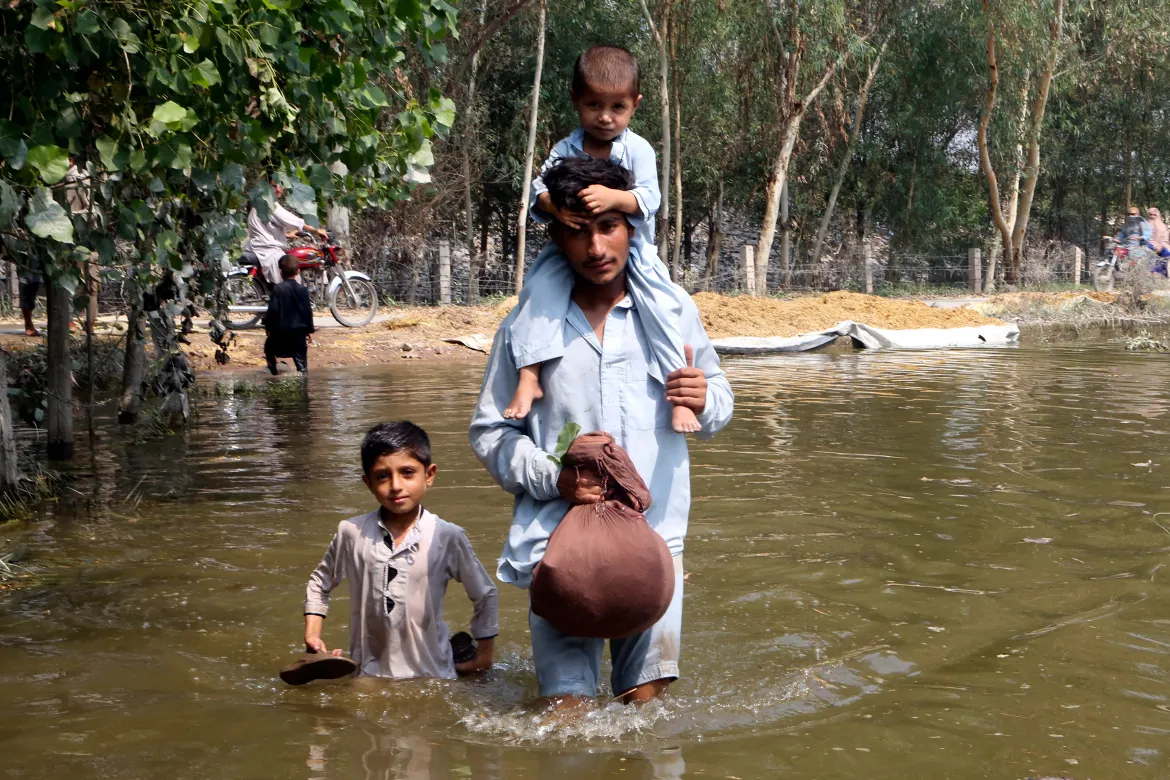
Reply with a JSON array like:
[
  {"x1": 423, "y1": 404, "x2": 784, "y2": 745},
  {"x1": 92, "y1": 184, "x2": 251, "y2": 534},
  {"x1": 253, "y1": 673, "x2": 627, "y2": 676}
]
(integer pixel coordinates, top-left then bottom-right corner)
[{"x1": 530, "y1": 433, "x2": 674, "y2": 639}]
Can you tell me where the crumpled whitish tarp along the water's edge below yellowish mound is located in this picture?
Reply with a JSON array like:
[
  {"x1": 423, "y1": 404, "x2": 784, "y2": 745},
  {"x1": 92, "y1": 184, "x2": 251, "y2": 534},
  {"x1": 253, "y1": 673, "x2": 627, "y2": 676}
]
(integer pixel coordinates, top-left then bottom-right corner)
[{"x1": 711, "y1": 320, "x2": 1020, "y2": 354}]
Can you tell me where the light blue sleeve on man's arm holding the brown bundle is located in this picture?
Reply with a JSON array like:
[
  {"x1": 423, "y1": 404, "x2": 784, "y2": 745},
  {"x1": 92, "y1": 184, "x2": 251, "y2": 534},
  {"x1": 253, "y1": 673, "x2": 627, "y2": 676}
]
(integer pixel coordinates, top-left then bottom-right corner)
[{"x1": 469, "y1": 320, "x2": 560, "y2": 501}]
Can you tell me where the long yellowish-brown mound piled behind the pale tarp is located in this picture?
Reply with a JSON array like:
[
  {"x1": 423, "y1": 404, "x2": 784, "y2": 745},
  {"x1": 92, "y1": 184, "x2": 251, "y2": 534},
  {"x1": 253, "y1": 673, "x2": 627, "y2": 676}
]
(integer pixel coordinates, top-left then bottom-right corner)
[{"x1": 694, "y1": 292, "x2": 1002, "y2": 338}]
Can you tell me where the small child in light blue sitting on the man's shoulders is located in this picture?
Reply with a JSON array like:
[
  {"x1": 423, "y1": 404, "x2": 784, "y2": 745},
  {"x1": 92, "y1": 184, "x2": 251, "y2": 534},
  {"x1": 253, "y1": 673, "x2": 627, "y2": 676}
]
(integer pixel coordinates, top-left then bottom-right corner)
[{"x1": 503, "y1": 46, "x2": 701, "y2": 433}]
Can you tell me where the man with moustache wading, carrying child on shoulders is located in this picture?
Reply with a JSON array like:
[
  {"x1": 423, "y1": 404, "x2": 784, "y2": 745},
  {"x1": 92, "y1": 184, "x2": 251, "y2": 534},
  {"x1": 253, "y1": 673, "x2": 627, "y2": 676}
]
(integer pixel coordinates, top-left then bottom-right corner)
[{"x1": 470, "y1": 159, "x2": 734, "y2": 703}]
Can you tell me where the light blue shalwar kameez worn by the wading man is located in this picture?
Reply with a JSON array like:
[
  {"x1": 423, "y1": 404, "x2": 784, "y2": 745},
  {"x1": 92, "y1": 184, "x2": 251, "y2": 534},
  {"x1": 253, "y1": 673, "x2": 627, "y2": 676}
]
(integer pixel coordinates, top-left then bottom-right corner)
[{"x1": 470, "y1": 291, "x2": 735, "y2": 696}]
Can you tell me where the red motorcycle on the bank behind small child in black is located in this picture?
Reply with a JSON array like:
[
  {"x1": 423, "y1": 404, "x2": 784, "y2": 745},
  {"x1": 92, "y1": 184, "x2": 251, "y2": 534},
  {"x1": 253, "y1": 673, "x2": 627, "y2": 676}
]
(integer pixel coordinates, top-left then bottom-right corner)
[{"x1": 223, "y1": 234, "x2": 378, "y2": 330}]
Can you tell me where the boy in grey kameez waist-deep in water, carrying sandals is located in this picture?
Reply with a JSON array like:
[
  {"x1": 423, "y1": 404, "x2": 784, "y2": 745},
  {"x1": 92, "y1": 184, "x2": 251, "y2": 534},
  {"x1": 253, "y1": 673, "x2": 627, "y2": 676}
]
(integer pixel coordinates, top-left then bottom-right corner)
[{"x1": 281, "y1": 420, "x2": 498, "y2": 685}]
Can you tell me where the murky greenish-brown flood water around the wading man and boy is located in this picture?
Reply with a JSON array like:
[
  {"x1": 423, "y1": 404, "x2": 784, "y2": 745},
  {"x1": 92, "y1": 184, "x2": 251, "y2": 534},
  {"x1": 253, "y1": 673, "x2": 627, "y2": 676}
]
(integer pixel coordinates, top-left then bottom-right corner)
[{"x1": 0, "y1": 344, "x2": 1170, "y2": 780}]
